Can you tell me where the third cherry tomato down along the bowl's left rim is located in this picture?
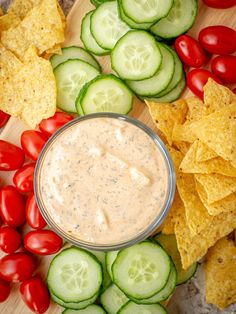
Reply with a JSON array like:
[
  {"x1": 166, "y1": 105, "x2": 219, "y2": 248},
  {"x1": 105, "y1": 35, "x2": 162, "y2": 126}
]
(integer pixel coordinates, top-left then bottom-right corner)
[{"x1": 13, "y1": 163, "x2": 35, "y2": 193}]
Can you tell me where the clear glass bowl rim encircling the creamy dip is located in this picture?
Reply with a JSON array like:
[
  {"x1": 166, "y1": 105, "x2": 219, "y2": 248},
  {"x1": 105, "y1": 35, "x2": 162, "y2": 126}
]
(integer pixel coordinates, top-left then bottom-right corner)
[{"x1": 34, "y1": 112, "x2": 176, "y2": 251}]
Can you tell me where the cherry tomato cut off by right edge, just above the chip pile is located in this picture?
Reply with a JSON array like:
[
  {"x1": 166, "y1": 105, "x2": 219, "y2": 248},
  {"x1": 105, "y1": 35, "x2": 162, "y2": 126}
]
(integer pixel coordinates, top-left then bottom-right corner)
[{"x1": 211, "y1": 56, "x2": 236, "y2": 83}]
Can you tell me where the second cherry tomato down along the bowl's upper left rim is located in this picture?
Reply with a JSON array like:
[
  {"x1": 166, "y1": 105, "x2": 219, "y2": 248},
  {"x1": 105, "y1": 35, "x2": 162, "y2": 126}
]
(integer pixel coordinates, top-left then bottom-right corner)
[{"x1": 21, "y1": 130, "x2": 48, "y2": 160}]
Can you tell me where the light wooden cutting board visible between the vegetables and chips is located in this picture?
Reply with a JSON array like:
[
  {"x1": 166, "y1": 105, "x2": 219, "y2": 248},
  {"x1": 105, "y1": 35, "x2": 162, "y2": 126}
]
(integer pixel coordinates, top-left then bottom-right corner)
[{"x1": 0, "y1": 0, "x2": 236, "y2": 314}]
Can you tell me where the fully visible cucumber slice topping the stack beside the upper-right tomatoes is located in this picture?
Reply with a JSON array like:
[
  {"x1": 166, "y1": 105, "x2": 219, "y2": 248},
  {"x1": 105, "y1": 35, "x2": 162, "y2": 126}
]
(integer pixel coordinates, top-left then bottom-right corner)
[{"x1": 111, "y1": 30, "x2": 162, "y2": 80}]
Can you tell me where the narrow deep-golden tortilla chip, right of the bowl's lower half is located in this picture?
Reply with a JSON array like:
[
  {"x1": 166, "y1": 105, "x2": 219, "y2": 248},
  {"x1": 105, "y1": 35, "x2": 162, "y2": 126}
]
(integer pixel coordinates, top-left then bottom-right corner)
[{"x1": 176, "y1": 173, "x2": 213, "y2": 235}]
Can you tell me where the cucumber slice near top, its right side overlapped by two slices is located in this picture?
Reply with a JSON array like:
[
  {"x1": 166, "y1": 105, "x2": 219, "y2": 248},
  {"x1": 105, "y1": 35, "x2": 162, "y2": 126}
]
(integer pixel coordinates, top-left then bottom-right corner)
[{"x1": 90, "y1": 1, "x2": 130, "y2": 49}]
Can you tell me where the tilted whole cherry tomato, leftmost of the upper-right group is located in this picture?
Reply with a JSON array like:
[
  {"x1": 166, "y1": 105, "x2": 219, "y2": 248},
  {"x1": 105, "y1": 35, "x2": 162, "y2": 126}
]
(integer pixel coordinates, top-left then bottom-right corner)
[{"x1": 175, "y1": 35, "x2": 207, "y2": 68}]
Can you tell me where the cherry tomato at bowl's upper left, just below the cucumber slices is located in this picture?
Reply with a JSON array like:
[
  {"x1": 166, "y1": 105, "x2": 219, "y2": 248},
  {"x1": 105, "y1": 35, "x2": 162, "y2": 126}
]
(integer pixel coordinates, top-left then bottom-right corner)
[{"x1": 39, "y1": 112, "x2": 73, "y2": 136}]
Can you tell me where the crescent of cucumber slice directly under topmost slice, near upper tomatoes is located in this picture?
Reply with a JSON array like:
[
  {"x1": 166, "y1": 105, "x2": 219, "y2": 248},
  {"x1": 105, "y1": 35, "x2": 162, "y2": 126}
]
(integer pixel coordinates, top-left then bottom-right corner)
[{"x1": 126, "y1": 44, "x2": 175, "y2": 96}]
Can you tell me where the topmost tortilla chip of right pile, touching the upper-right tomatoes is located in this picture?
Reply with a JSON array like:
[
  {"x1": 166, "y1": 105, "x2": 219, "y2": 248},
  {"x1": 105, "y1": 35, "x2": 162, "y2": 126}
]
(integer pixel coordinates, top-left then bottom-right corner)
[{"x1": 203, "y1": 78, "x2": 236, "y2": 114}]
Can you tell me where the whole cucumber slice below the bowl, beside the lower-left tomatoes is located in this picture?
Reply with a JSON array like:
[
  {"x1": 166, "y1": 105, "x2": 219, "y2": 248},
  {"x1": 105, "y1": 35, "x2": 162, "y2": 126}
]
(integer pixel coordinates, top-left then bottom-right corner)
[{"x1": 47, "y1": 247, "x2": 103, "y2": 303}]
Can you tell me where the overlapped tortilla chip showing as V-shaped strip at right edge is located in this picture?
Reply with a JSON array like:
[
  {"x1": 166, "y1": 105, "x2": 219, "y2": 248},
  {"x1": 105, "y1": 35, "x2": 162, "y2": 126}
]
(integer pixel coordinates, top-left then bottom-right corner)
[{"x1": 196, "y1": 181, "x2": 236, "y2": 216}]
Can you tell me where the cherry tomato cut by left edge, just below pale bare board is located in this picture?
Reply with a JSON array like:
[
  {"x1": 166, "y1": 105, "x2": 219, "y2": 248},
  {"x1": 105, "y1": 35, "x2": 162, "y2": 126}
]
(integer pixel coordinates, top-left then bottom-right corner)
[{"x1": 0, "y1": 140, "x2": 25, "y2": 171}]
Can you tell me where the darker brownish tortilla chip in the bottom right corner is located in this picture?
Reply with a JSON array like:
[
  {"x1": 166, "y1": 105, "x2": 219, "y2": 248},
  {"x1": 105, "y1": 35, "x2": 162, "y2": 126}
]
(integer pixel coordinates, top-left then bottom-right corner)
[{"x1": 204, "y1": 238, "x2": 236, "y2": 310}]
